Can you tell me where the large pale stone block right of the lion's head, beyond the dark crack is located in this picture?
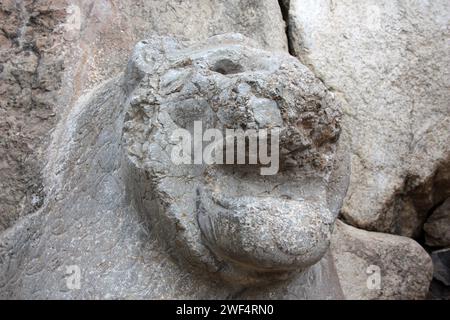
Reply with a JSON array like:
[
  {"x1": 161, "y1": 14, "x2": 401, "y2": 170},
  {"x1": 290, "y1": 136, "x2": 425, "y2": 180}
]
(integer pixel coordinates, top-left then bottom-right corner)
[{"x1": 289, "y1": 0, "x2": 450, "y2": 237}]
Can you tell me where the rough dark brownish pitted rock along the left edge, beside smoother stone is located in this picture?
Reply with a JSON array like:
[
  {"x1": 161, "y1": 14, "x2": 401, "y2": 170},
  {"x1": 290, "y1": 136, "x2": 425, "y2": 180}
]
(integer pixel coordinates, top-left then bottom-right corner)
[{"x1": 0, "y1": 0, "x2": 66, "y2": 231}]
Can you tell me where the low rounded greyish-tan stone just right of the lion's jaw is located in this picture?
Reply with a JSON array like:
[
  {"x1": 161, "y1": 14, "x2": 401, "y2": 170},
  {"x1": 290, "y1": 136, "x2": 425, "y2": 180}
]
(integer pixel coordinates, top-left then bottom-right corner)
[{"x1": 331, "y1": 220, "x2": 433, "y2": 300}]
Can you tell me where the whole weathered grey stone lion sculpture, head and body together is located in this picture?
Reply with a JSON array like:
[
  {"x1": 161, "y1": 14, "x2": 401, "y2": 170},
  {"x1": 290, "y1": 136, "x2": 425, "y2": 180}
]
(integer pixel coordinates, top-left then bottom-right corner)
[{"x1": 0, "y1": 34, "x2": 349, "y2": 299}]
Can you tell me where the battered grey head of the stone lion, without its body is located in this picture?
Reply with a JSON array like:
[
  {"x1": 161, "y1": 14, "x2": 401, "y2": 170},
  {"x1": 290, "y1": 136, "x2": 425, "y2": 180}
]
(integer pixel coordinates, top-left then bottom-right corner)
[{"x1": 124, "y1": 34, "x2": 347, "y2": 283}]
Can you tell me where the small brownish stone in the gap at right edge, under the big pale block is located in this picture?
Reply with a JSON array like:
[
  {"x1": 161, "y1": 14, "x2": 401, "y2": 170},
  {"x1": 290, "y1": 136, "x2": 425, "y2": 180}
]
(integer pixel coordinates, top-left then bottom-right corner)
[{"x1": 423, "y1": 198, "x2": 450, "y2": 247}]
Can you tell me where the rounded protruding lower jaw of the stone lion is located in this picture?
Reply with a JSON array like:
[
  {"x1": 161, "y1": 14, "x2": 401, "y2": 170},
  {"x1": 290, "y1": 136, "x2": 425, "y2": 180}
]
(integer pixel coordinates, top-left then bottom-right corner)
[{"x1": 197, "y1": 189, "x2": 334, "y2": 272}]
